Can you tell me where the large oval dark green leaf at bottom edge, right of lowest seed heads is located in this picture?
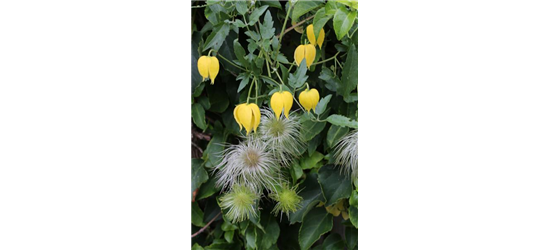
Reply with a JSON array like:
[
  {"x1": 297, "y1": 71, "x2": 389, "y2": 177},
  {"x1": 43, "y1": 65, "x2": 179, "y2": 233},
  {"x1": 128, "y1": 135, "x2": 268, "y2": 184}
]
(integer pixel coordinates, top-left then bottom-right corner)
[{"x1": 299, "y1": 207, "x2": 334, "y2": 249}]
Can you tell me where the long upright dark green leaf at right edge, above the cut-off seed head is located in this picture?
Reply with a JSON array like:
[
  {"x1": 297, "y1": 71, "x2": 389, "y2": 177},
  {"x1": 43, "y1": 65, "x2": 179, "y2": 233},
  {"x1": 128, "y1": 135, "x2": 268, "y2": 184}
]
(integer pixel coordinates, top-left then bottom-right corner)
[{"x1": 338, "y1": 44, "x2": 358, "y2": 103}]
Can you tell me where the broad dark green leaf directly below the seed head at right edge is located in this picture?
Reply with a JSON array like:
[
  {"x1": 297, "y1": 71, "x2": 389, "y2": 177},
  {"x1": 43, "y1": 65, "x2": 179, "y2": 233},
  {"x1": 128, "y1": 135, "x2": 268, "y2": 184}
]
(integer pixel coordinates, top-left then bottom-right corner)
[{"x1": 318, "y1": 165, "x2": 353, "y2": 206}]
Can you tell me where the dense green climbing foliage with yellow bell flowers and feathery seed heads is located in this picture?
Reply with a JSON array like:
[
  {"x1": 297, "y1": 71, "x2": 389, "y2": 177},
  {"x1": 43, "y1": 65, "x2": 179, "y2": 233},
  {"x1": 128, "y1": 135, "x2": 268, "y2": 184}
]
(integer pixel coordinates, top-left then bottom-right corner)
[{"x1": 191, "y1": 0, "x2": 358, "y2": 249}]
